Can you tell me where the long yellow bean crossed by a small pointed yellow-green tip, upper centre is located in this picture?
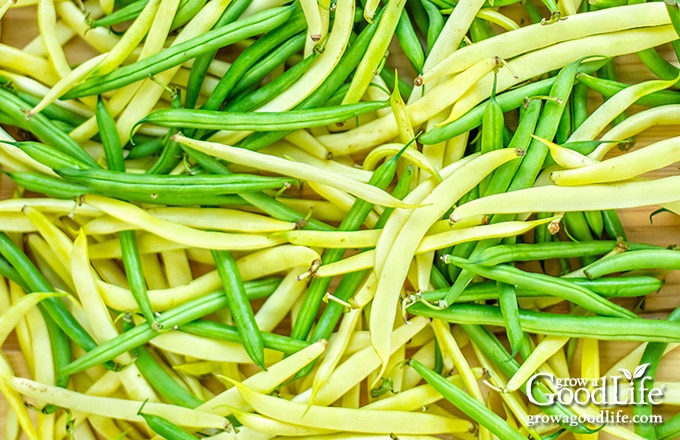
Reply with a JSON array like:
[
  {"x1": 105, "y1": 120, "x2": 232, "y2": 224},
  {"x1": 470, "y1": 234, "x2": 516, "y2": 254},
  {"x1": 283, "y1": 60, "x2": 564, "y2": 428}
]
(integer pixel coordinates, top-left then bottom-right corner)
[{"x1": 318, "y1": 58, "x2": 496, "y2": 156}]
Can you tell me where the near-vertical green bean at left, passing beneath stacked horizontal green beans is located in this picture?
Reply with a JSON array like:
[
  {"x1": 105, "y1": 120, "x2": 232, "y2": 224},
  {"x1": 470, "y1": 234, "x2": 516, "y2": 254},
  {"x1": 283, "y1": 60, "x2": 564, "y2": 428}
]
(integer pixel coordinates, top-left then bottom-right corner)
[{"x1": 95, "y1": 97, "x2": 156, "y2": 327}]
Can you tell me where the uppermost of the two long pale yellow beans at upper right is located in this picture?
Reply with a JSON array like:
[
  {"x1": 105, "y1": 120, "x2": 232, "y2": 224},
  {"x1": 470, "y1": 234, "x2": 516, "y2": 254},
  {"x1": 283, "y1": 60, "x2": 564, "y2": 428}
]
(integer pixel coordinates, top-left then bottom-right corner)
[{"x1": 419, "y1": 0, "x2": 669, "y2": 84}]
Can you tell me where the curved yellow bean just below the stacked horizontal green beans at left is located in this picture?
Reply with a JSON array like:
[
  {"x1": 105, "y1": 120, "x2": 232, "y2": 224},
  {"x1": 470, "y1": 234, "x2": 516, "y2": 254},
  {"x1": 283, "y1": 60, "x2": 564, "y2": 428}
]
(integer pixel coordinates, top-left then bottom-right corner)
[{"x1": 81, "y1": 194, "x2": 283, "y2": 250}]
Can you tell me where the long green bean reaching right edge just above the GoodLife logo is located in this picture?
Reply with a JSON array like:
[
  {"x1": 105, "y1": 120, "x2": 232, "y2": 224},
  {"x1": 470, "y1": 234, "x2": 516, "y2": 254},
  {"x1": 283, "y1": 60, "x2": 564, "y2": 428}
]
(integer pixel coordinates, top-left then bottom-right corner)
[{"x1": 409, "y1": 304, "x2": 680, "y2": 344}]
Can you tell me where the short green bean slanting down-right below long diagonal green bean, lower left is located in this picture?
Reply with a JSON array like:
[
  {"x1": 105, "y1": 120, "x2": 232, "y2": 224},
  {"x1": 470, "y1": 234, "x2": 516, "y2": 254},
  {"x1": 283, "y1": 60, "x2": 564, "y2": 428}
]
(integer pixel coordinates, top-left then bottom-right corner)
[{"x1": 123, "y1": 315, "x2": 203, "y2": 408}]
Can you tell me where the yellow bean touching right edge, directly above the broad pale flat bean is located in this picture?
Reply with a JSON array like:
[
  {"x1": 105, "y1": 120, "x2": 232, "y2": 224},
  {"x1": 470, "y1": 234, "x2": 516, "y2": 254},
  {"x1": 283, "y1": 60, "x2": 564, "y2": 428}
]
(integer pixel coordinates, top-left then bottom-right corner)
[{"x1": 550, "y1": 137, "x2": 680, "y2": 186}]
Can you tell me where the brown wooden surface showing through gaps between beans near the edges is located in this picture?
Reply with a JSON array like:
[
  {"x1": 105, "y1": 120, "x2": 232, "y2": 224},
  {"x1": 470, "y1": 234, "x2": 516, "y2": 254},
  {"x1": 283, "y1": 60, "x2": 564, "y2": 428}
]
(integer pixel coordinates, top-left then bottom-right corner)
[{"x1": 0, "y1": 3, "x2": 680, "y2": 438}]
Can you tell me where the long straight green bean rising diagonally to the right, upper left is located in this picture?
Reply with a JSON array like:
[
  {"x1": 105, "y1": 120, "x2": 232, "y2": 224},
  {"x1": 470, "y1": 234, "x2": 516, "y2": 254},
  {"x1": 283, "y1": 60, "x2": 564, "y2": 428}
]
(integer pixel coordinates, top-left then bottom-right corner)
[{"x1": 62, "y1": 7, "x2": 292, "y2": 99}]
